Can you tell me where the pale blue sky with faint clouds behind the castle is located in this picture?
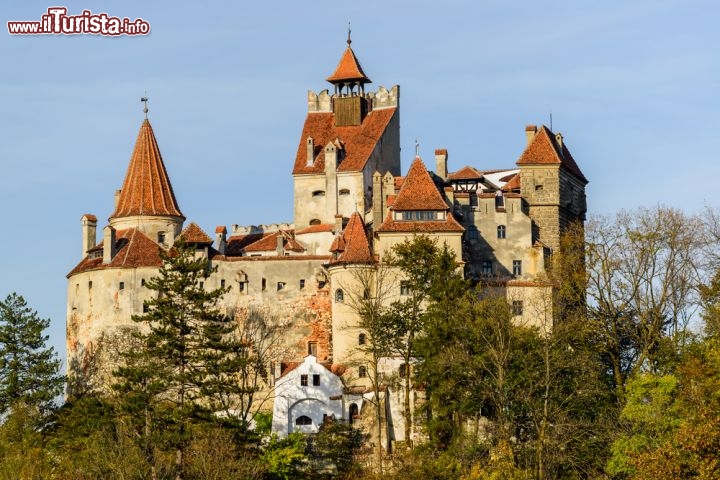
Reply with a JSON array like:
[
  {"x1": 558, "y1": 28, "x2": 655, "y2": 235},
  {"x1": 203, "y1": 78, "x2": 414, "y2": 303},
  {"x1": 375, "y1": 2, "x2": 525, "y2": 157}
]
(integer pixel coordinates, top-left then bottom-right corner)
[{"x1": 0, "y1": 0, "x2": 720, "y2": 368}]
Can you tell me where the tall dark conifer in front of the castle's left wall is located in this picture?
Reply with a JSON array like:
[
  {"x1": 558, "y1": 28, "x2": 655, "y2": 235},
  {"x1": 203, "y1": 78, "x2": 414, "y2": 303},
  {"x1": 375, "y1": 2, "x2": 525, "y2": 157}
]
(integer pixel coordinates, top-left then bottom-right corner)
[{"x1": 116, "y1": 244, "x2": 245, "y2": 480}]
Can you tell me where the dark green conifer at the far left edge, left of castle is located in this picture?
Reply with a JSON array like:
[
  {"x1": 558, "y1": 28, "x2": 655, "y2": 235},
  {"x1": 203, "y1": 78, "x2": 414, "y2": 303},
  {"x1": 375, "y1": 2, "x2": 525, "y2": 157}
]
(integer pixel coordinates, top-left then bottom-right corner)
[{"x1": 0, "y1": 293, "x2": 65, "y2": 415}]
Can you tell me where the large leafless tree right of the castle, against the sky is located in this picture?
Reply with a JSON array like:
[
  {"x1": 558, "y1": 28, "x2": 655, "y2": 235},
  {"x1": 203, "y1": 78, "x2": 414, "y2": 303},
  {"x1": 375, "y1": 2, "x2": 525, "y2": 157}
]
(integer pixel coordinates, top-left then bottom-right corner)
[{"x1": 587, "y1": 207, "x2": 702, "y2": 399}]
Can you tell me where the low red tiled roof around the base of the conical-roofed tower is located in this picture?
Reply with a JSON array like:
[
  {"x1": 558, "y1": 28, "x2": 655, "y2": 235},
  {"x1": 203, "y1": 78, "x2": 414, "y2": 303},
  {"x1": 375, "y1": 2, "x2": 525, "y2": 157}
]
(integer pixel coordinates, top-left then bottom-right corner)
[{"x1": 67, "y1": 228, "x2": 163, "y2": 278}]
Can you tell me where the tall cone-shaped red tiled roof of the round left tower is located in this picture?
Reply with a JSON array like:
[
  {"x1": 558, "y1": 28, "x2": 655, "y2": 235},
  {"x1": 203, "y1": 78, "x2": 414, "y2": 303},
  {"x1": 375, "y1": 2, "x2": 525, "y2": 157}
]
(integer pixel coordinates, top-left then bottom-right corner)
[{"x1": 110, "y1": 119, "x2": 184, "y2": 219}]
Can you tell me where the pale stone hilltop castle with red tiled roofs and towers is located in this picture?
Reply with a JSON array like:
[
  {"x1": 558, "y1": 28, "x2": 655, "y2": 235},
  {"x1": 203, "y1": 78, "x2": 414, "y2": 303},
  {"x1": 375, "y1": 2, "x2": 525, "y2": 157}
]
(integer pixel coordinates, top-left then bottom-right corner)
[{"x1": 67, "y1": 35, "x2": 587, "y2": 440}]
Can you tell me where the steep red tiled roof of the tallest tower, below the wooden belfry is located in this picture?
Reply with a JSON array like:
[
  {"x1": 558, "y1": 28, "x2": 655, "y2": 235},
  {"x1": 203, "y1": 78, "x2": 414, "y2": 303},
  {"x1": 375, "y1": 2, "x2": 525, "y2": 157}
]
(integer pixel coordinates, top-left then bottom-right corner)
[{"x1": 293, "y1": 108, "x2": 397, "y2": 175}]
